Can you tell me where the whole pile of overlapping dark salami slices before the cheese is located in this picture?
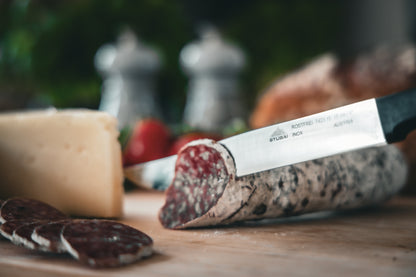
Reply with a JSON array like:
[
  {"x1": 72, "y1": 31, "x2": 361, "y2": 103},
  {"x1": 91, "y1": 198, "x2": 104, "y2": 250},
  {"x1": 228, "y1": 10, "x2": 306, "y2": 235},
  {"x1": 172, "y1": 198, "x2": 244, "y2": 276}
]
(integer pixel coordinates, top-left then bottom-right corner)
[{"x1": 0, "y1": 198, "x2": 153, "y2": 267}]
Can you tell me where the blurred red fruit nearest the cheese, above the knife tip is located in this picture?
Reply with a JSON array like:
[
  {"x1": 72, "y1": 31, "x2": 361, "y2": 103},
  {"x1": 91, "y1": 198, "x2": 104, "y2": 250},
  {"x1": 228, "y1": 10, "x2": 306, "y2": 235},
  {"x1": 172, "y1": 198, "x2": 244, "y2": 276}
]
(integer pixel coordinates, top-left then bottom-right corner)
[{"x1": 123, "y1": 118, "x2": 171, "y2": 166}]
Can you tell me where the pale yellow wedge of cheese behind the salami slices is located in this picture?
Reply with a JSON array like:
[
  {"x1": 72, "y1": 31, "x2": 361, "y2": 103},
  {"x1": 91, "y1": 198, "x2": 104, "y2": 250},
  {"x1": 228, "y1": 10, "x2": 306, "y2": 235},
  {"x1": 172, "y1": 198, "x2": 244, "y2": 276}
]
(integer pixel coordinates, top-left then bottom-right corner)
[{"x1": 0, "y1": 109, "x2": 123, "y2": 217}]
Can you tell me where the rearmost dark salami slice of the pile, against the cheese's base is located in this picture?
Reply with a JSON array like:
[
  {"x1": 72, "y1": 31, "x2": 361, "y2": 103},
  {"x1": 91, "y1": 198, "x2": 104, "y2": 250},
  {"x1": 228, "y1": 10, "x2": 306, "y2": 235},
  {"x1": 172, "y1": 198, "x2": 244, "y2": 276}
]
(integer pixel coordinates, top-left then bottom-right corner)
[{"x1": 0, "y1": 198, "x2": 68, "y2": 223}]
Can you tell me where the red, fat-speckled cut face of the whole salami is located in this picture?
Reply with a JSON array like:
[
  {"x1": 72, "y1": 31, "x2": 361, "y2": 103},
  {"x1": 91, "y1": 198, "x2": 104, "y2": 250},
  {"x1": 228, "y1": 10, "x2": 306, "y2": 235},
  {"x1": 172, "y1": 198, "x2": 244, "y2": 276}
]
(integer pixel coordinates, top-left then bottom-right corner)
[{"x1": 159, "y1": 139, "x2": 235, "y2": 229}]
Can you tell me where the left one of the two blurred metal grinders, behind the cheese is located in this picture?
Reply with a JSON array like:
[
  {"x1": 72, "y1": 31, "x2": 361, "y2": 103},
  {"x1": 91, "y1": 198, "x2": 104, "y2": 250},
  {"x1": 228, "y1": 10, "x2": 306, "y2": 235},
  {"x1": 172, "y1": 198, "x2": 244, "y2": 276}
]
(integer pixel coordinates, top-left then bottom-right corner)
[{"x1": 94, "y1": 30, "x2": 161, "y2": 129}]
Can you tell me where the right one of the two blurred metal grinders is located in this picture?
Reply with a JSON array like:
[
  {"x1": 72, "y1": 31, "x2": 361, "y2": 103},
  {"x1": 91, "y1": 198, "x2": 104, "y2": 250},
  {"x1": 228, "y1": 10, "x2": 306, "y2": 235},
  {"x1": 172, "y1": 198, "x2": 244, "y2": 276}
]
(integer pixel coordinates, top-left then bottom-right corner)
[{"x1": 180, "y1": 27, "x2": 245, "y2": 132}]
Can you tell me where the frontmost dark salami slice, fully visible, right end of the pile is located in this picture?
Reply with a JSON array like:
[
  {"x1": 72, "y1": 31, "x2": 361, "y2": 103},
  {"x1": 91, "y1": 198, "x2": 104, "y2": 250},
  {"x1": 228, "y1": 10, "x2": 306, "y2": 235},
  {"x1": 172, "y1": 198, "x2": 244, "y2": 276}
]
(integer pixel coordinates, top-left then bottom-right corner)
[{"x1": 61, "y1": 220, "x2": 153, "y2": 267}]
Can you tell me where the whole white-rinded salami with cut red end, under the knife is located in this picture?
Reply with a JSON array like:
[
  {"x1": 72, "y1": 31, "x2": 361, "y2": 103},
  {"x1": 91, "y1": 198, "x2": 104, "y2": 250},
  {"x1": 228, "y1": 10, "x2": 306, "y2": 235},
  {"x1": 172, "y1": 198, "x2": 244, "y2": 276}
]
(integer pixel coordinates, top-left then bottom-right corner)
[{"x1": 159, "y1": 140, "x2": 407, "y2": 229}]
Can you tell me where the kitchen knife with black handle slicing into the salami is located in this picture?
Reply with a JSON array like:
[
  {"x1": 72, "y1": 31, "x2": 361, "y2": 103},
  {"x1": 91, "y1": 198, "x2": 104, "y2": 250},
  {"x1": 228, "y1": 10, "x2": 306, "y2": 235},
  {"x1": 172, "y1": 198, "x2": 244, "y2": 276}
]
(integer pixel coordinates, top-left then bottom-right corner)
[{"x1": 124, "y1": 89, "x2": 416, "y2": 190}]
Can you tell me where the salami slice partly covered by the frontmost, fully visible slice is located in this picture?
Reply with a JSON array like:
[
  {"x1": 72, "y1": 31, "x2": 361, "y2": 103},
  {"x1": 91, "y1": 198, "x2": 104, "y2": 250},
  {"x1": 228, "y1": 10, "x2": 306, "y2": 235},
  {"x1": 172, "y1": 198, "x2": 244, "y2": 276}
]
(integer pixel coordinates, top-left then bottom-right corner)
[{"x1": 31, "y1": 220, "x2": 70, "y2": 253}]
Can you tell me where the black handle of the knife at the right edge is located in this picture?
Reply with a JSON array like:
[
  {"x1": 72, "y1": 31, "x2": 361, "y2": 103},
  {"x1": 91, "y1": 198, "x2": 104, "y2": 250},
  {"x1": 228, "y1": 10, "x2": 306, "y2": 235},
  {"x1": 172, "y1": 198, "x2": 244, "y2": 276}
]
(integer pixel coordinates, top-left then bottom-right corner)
[{"x1": 376, "y1": 88, "x2": 416, "y2": 143}]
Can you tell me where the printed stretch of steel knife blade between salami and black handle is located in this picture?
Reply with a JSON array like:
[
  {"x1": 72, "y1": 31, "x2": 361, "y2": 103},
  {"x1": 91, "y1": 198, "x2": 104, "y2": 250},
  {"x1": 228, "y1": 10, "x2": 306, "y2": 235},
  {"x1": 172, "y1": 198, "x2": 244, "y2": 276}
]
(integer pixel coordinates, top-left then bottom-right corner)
[{"x1": 221, "y1": 99, "x2": 386, "y2": 176}]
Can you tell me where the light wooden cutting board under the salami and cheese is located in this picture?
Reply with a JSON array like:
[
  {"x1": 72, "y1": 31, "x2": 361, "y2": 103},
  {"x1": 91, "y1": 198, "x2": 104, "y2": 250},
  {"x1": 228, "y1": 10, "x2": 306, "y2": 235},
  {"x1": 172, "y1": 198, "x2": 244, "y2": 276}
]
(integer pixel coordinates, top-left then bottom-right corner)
[{"x1": 0, "y1": 191, "x2": 416, "y2": 277}]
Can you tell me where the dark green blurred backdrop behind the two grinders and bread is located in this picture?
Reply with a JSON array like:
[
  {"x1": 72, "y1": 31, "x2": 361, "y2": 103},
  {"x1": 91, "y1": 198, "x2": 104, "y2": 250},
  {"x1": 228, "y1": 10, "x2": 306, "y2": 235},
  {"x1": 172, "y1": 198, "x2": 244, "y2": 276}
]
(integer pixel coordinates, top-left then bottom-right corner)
[{"x1": 0, "y1": 0, "x2": 414, "y2": 121}]
